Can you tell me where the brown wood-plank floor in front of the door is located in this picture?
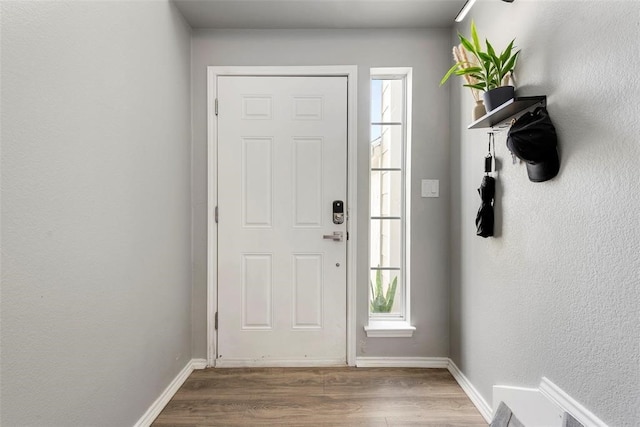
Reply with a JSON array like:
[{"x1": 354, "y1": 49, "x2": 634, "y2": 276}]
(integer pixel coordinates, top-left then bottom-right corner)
[{"x1": 153, "y1": 367, "x2": 487, "y2": 427}]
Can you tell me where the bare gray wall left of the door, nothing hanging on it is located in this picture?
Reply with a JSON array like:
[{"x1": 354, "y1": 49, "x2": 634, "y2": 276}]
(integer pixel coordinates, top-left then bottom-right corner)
[{"x1": 0, "y1": 1, "x2": 191, "y2": 426}]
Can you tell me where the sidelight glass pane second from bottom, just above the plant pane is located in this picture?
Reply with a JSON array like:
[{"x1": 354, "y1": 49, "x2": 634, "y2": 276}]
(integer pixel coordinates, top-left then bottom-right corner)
[{"x1": 369, "y1": 219, "x2": 402, "y2": 268}]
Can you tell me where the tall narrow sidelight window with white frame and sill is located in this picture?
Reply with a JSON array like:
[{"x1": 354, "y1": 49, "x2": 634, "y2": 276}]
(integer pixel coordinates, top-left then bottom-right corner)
[{"x1": 365, "y1": 68, "x2": 415, "y2": 336}]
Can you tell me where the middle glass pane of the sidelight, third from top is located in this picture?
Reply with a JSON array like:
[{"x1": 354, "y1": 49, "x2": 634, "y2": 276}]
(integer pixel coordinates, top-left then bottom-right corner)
[{"x1": 369, "y1": 171, "x2": 402, "y2": 217}]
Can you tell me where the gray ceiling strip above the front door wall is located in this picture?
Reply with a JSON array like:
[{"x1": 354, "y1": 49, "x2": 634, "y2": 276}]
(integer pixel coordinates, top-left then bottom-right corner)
[{"x1": 173, "y1": 0, "x2": 465, "y2": 29}]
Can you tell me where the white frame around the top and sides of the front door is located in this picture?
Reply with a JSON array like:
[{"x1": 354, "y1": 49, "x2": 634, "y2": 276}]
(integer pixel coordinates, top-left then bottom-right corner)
[{"x1": 207, "y1": 65, "x2": 358, "y2": 367}]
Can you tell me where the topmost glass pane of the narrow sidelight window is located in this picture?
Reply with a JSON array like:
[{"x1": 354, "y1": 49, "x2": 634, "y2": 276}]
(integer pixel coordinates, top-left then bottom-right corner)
[{"x1": 371, "y1": 80, "x2": 404, "y2": 123}]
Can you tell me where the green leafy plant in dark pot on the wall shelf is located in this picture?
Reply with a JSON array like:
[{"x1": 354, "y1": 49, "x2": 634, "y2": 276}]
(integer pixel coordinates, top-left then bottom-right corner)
[{"x1": 440, "y1": 21, "x2": 520, "y2": 111}]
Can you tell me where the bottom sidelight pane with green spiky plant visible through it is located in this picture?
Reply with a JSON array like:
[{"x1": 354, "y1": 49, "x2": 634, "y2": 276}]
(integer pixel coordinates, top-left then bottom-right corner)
[{"x1": 369, "y1": 270, "x2": 404, "y2": 317}]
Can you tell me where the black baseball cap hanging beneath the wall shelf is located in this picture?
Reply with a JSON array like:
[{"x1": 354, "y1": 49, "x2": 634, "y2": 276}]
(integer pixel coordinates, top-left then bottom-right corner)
[{"x1": 507, "y1": 107, "x2": 560, "y2": 182}]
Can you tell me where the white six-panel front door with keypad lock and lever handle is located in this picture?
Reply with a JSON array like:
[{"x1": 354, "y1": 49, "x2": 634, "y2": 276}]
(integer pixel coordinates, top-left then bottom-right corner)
[{"x1": 216, "y1": 76, "x2": 347, "y2": 366}]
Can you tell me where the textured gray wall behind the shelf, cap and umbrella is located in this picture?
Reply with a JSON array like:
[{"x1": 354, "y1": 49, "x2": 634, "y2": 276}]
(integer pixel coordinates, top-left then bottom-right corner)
[{"x1": 450, "y1": 0, "x2": 640, "y2": 426}]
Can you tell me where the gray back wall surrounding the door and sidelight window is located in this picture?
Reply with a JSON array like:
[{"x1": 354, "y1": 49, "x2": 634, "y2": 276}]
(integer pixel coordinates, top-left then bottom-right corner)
[{"x1": 192, "y1": 30, "x2": 450, "y2": 357}]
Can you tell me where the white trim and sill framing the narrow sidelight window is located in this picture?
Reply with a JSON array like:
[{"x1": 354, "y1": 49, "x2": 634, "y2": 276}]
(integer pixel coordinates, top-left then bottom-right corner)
[{"x1": 364, "y1": 67, "x2": 416, "y2": 338}]
